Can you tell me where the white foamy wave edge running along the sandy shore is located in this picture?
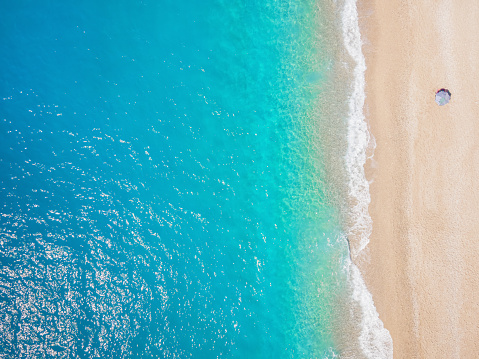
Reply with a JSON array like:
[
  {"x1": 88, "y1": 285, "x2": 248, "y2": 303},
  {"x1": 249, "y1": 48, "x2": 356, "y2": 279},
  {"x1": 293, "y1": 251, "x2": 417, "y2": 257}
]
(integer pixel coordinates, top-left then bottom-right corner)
[{"x1": 342, "y1": 0, "x2": 393, "y2": 359}]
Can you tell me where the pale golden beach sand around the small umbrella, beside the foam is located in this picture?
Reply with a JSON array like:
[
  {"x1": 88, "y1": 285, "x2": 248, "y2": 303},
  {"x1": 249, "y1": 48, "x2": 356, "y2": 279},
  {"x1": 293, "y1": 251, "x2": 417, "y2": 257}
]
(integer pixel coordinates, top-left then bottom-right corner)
[{"x1": 356, "y1": 0, "x2": 479, "y2": 359}]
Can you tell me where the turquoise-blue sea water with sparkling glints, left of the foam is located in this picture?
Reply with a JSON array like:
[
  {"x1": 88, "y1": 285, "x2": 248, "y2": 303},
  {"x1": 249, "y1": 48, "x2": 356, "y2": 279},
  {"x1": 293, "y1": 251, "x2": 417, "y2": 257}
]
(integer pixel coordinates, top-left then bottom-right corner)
[{"x1": 0, "y1": 0, "x2": 347, "y2": 358}]
